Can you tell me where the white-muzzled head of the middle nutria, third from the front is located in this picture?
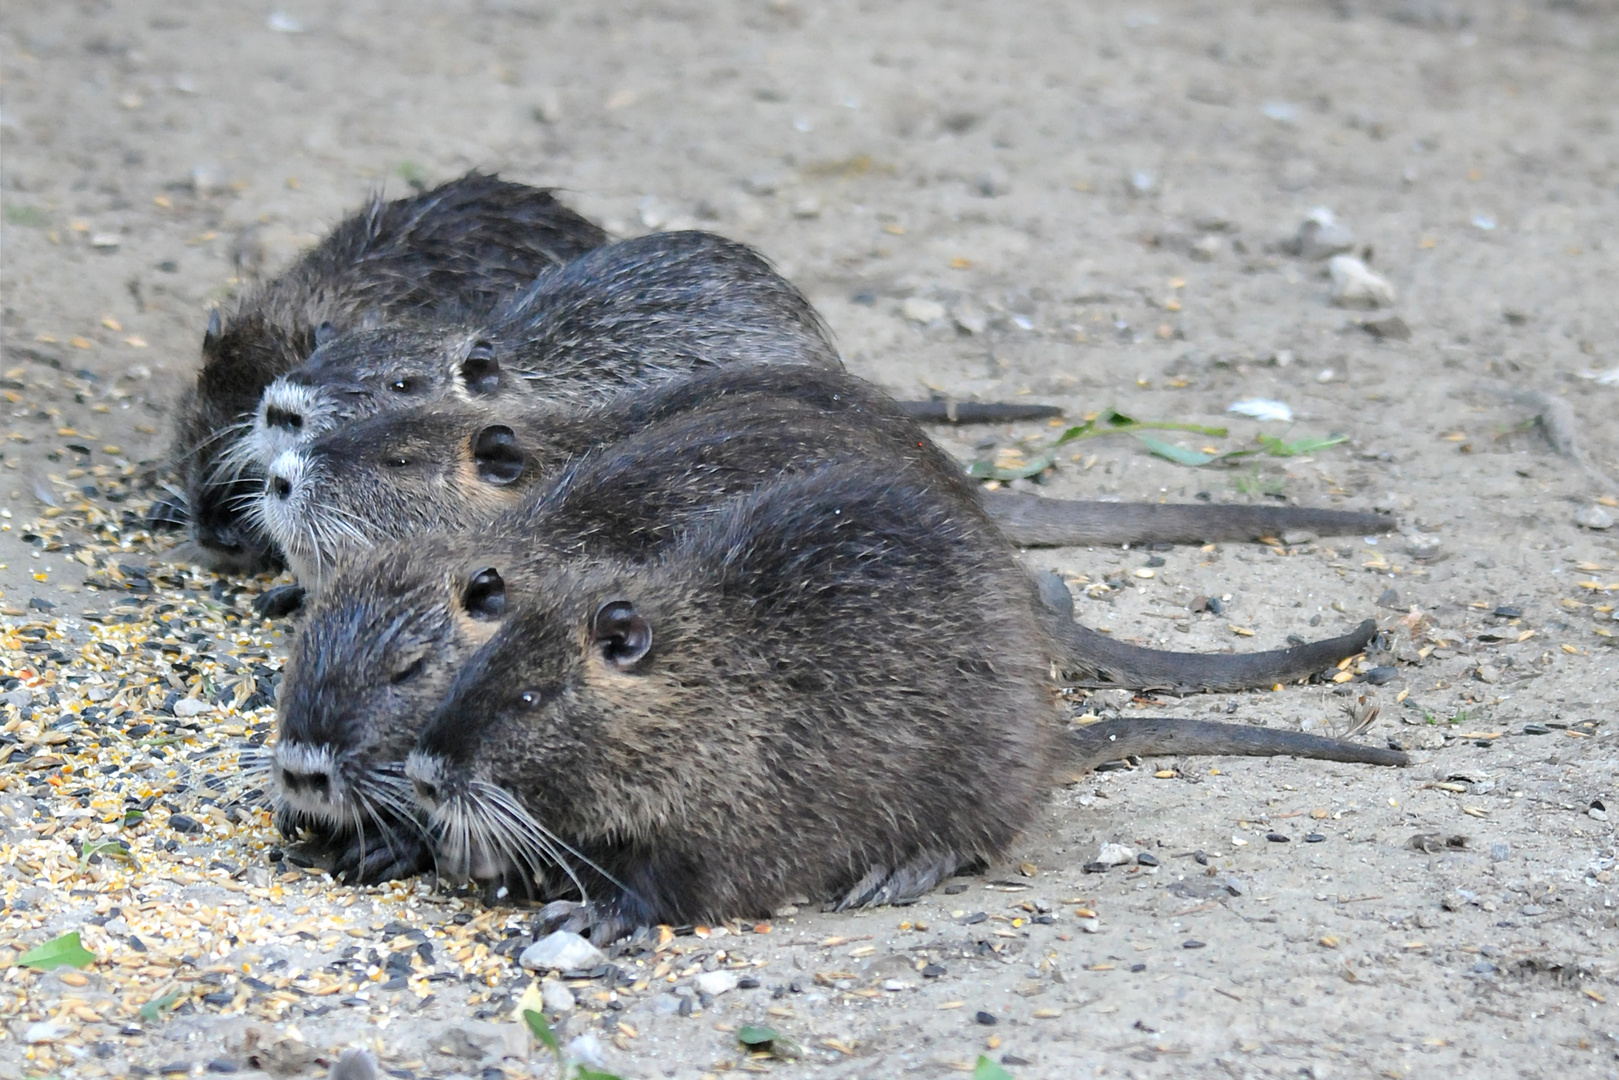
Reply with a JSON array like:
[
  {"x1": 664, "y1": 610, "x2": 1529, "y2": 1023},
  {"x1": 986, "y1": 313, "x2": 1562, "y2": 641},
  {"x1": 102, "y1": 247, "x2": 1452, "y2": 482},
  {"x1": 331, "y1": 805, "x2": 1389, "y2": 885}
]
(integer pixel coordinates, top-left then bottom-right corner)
[{"x1": 257, "y1": 402, "x2": 544, "y2": 588}]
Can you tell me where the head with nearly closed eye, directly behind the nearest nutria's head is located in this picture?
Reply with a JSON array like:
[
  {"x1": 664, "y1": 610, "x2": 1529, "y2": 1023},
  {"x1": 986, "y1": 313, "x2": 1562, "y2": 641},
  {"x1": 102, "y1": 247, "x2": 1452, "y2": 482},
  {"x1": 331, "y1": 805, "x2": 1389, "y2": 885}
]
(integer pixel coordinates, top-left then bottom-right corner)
[{"x1": 270, "y1": 538, "x2": 505, "y2": 829}]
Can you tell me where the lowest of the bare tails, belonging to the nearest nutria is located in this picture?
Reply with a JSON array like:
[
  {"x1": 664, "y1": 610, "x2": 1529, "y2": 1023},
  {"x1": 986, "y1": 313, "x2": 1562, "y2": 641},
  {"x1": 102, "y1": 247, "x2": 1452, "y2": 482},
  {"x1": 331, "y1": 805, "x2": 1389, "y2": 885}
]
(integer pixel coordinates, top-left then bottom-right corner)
[{"x1": 1062, "y1": 716, "x2": 1410, "y2": 772}]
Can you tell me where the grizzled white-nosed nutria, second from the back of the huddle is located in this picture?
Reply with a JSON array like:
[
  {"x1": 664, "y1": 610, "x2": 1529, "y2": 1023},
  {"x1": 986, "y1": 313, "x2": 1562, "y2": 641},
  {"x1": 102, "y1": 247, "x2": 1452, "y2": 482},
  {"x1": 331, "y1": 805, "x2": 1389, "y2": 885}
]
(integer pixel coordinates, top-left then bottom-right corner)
[{"x1": 249, "y1": 232, "x2": 842, "y2": 465}]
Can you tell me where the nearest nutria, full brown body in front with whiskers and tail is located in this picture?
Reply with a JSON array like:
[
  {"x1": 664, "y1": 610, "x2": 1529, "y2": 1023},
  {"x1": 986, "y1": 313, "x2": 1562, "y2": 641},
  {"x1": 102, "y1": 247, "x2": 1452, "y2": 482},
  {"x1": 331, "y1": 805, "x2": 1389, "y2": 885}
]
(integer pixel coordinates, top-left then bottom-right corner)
[{"x1": 406, "y1": 460, "x2": 1405, "y2": 939}]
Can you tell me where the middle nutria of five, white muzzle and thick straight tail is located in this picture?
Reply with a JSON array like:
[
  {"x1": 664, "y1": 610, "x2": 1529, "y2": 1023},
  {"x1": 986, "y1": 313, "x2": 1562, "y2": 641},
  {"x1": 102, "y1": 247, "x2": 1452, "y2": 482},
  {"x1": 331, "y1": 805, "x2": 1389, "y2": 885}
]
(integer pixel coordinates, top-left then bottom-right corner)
[{"x1": 257, "y1": 363, "x2": 1389, "y2": 586}]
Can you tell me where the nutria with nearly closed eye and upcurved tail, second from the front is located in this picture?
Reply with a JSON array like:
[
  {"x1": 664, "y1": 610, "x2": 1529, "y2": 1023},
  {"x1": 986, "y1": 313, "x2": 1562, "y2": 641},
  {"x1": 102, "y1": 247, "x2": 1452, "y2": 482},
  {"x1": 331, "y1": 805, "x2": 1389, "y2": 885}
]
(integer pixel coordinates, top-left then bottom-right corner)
[{"x1": 272, "y1": 366, "x2": 1375, "y2": 879}]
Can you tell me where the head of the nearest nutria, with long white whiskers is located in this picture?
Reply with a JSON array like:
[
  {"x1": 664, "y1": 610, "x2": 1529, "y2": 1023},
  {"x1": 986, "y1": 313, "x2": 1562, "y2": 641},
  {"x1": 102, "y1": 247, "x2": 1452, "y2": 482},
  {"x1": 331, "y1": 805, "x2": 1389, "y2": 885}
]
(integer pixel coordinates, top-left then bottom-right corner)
[{"x1": 405, "y1": 567, "x2": 676, "y2": 895}]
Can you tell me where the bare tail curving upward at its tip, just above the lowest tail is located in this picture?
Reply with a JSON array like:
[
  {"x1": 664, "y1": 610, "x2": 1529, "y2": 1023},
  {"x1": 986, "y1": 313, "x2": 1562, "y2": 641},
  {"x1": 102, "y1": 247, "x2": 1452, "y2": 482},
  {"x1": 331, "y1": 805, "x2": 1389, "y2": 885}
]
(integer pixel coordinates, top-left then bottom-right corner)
[{"x1": 1051, "y1": 612, "x2": 1378, "y2": 693}]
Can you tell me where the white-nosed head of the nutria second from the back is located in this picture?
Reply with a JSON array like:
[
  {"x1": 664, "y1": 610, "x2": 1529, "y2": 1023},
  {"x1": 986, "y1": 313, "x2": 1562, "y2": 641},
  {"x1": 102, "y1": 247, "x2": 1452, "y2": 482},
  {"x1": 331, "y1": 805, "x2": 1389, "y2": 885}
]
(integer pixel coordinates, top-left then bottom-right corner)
[{"x1": 244, "y1": 325, "x2": 507, "y2": 466}]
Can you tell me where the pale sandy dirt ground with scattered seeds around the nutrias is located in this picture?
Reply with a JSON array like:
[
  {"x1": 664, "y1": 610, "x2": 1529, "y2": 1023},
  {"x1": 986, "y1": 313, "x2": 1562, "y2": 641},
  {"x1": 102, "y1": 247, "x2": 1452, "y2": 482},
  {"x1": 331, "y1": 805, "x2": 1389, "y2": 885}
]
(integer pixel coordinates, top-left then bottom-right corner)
[{"x1": 0, "y1": 0, "x2": 1619, "y2": 1080}]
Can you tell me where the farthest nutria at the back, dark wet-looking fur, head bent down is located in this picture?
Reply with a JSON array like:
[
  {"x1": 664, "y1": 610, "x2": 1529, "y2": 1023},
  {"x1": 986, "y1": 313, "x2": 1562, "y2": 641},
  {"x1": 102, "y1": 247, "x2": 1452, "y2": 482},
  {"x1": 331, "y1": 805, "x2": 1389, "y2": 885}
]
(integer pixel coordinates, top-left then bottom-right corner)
[{"x1": 165, "y1": 172, "x2": 607, "y2": 570}]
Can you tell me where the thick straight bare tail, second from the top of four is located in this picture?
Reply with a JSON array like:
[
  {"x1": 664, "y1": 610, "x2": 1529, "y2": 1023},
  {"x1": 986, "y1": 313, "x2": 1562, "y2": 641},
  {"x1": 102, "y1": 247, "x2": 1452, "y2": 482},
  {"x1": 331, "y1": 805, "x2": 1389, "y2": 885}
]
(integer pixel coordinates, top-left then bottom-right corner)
[{"x1": 979, "y1": 491, "x2": 1394, "y2": 547}]
